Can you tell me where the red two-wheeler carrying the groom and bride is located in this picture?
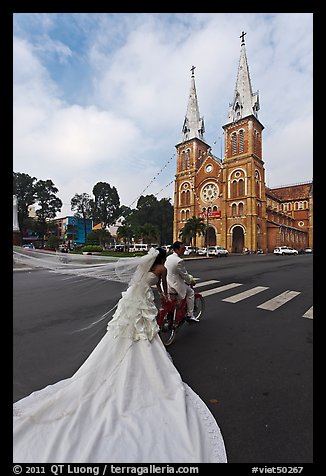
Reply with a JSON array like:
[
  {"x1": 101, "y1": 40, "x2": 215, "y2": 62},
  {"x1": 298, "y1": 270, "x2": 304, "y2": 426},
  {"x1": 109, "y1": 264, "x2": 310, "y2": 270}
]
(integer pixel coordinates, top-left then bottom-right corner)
[{"x1": 157, "y1": 286, "x2": 205, "y2": 347}]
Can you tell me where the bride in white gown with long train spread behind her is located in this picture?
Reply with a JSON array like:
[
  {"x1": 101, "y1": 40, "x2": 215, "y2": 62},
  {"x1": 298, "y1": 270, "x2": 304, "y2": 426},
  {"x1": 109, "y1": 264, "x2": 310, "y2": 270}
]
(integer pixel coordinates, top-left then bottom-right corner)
[{"x1": 13, "y1": 248, "x2": 227, "y2": 463}]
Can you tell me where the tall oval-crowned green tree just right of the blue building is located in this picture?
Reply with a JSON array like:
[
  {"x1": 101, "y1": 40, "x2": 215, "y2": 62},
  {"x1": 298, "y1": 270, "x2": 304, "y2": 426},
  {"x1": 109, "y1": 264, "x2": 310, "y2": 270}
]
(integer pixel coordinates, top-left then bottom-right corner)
[{"x1": 93, "y1": 182, "x2": 120, "y2": 228}]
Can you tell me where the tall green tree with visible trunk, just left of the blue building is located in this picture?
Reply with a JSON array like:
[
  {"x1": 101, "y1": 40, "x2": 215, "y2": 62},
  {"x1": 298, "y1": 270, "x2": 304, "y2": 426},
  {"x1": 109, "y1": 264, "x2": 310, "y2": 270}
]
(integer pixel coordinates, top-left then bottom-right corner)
[{"x1": 35, "y1": 180, "x2": 62, "y2": 247}]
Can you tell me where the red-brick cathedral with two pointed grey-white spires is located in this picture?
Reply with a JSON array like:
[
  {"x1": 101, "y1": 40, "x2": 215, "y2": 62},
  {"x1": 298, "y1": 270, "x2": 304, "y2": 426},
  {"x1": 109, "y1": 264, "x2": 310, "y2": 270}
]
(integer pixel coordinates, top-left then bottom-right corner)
[{"x1": 173, "y1": 33, "x2": 313, "y2": 253}]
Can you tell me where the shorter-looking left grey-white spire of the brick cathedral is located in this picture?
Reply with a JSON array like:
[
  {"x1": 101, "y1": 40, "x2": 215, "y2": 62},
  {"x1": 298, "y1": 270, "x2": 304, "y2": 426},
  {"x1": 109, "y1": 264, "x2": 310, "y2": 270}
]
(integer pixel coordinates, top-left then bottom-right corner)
[{"x1": 182, "y1": 66, "x2": 205, "y2": 142}]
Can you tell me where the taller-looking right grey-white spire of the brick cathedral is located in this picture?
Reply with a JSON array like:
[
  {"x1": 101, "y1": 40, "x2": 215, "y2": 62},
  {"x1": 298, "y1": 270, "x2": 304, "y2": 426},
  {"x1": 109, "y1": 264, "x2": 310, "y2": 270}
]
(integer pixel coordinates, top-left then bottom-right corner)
[{"x1": 228, "y1": 31, "x2": 259, "y2": 122}]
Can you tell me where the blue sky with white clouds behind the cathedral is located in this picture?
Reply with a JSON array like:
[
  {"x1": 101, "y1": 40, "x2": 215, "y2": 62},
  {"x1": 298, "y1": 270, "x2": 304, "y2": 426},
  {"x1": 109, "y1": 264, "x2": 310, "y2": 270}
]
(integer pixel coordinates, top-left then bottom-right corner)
[{"x1": 13, "y1": 13, "x2": 313, "y2": 217}]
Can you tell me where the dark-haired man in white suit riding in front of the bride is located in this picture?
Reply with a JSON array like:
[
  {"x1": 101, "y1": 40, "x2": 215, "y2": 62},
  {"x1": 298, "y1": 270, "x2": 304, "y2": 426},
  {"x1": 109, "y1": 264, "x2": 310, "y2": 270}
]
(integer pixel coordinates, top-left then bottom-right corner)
[{"x1": 165, "y1": 241, "x2": 199, "y2": 322}]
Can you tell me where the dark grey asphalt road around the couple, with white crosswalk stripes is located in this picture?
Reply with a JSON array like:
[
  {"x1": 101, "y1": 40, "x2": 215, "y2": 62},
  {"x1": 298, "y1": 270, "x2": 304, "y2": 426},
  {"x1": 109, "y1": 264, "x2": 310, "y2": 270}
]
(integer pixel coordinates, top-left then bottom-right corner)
[{"x1": 13, "y1": 255, "x2": 313, "y2": 464}]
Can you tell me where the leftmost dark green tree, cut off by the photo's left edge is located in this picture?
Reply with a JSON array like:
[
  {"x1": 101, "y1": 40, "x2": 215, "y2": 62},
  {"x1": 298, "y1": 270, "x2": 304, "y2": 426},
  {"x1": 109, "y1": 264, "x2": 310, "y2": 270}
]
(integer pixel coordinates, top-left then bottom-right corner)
[{"x1": 13, "y1": 172, "x2": 37, "y2": 229}]
